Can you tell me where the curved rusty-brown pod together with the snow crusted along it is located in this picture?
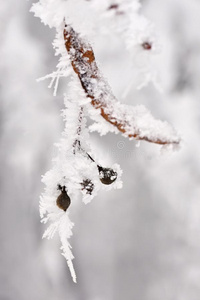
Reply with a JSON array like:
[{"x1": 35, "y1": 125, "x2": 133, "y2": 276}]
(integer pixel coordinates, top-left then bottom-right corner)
[{"x1": 63, "y1": 25, "x2": 180, "y2": 145}]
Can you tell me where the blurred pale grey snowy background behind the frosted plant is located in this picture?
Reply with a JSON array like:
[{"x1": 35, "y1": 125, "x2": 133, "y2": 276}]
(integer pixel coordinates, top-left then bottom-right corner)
[{"x1": 0, "y1": 0, "x2": 200, "y2": 300}]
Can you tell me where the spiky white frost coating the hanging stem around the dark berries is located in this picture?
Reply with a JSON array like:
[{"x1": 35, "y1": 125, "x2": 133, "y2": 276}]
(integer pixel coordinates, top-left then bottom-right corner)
[{"x1": 37, "y1": 76, "x2": 122, "y2": 282}]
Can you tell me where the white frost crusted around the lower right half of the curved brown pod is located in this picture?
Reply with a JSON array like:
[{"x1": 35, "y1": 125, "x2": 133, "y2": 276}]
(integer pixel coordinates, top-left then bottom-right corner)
[{"x1": 86, "y1": 99, "x2": 179, "y2": 143}]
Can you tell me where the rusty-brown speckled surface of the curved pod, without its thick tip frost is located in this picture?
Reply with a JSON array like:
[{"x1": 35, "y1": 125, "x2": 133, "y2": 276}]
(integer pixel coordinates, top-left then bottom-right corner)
[{"x1": 63, "y1": 25, "x2": 180, "y2": 145}]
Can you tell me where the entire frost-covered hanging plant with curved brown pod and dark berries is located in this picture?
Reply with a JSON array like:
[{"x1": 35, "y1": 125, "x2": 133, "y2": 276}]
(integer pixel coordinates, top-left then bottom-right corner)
[{"x1": 31, "y1": 0, "x2": 180, "y2": 282}]
